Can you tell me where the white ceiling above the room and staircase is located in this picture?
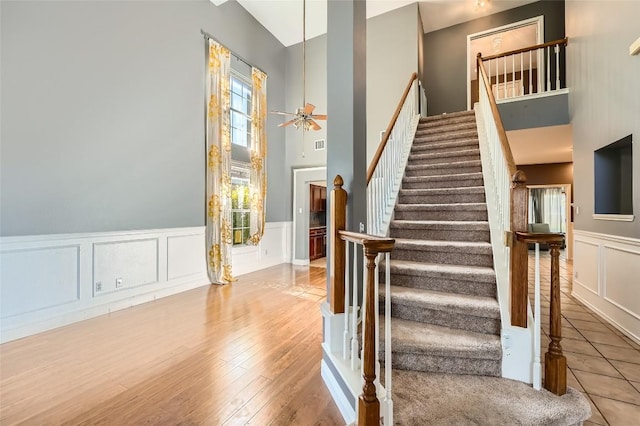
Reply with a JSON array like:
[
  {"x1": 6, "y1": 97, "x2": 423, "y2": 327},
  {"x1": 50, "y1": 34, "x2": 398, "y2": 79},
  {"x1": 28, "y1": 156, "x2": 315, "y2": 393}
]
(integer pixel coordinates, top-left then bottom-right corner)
[{"x1": 210, "y1": 0, "x2": 537, "y2": 46}]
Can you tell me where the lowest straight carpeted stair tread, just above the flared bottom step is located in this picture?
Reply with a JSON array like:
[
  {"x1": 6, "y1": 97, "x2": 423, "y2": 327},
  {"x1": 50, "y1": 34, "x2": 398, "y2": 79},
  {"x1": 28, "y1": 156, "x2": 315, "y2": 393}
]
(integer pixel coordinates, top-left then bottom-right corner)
[{"x1": 380, "y1": 315, "x2": 502, "y2": 361}]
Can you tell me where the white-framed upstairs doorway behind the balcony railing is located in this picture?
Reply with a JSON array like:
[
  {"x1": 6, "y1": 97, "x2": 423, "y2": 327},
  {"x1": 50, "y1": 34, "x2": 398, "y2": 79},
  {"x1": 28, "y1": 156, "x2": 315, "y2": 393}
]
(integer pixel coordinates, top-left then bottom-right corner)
[{"x1": 467, "y1": 16, "x2": 544, "y2": 110}]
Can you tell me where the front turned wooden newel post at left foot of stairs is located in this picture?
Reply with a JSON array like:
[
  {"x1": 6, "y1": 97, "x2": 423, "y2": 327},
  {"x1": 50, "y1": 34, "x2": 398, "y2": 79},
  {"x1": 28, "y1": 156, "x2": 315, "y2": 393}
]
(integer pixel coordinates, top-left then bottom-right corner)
[{"x1": 358, "y1": 244, "x2": 380, "y2": 426}]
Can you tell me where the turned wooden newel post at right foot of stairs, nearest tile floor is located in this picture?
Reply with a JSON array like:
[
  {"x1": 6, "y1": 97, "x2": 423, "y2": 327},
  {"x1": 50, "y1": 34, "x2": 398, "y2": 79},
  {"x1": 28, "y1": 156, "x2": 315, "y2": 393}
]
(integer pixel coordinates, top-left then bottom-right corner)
[{"x1": 544, "y1": 242, "x2": 567, "y2": 395}]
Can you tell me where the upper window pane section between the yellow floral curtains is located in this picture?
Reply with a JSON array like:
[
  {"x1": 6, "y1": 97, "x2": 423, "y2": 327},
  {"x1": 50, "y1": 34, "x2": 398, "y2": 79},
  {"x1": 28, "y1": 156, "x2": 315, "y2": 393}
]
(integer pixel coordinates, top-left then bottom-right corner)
[{"x1": 230, "y1": 72, "x2": 251, "y2": 149}]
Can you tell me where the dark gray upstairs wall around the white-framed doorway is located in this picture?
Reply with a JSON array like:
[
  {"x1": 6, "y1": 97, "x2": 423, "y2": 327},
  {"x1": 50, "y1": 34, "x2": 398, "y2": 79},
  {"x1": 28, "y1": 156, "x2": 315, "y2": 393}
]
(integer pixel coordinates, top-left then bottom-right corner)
[{"x1": 424, "y1": 1, "x2": 571, "y2": 115}]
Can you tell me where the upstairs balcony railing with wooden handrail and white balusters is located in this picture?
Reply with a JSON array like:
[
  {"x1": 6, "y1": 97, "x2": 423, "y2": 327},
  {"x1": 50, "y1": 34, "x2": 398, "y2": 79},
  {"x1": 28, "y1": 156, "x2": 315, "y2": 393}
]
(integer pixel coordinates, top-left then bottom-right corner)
[{"x1": 478, "y1": 38, "x2": 567, "y2": 100}]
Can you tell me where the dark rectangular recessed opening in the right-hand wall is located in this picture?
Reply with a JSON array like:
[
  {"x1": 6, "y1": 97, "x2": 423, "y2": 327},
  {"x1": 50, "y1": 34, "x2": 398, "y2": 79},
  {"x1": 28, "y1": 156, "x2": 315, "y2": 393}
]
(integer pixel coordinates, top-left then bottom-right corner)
[{"x1": 594, "y1": 135, "x2": 633, "y2": 216}]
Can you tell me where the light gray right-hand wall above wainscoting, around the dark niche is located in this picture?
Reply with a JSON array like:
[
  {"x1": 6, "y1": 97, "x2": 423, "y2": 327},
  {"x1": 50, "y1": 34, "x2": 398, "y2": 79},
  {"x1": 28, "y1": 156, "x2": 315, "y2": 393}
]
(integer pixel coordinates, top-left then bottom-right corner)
[{"x1": 566, "y1": 1, "x2": 640, "y2": 238}]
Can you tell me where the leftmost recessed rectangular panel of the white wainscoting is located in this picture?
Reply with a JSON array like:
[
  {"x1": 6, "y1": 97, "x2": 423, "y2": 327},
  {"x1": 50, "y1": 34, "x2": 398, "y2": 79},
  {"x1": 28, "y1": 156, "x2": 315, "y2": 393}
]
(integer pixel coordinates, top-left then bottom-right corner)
[{"x1": 0, "y1": 245, "x2": 80, "y2": 318}]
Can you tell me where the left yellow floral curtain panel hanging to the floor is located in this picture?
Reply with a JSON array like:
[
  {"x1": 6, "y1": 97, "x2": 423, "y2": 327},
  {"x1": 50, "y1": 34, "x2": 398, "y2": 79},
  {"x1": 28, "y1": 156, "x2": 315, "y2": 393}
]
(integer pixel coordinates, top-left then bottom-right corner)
[{"x1": 205, "y1": 40, "x2": 235, "y2": 284}]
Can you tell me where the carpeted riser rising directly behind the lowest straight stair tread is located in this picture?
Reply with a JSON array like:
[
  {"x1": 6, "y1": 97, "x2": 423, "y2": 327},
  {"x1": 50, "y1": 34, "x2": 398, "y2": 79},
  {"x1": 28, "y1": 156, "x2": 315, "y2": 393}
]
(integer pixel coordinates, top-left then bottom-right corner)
[{"x1": 380, "y1": 299, "x2": 500, "y2": 335}]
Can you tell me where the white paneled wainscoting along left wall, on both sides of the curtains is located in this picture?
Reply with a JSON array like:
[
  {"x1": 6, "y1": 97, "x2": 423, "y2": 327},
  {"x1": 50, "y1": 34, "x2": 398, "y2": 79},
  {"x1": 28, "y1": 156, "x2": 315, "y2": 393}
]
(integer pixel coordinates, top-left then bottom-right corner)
[{"x1": 0, "y1": 222, "x2": 292, "y2": 342}]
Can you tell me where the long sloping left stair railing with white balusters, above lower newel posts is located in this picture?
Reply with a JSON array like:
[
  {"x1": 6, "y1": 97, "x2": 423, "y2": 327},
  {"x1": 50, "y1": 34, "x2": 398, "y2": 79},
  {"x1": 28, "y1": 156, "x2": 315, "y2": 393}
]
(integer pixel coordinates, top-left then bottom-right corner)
[{"x1": 367, "y1": 73, "x2": 424, "y2": 240}]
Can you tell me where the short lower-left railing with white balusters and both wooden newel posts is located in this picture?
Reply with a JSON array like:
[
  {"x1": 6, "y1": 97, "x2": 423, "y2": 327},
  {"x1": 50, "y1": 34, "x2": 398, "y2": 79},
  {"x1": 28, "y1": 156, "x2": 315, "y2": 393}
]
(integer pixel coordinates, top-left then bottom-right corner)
[{"x1": 330, "y1": 175, "x2": 395, "y2": 426}]
